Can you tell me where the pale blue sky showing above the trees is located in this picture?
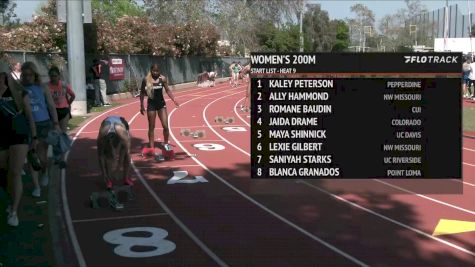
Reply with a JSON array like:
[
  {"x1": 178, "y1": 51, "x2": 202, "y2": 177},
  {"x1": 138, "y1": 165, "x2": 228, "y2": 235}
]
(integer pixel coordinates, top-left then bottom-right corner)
[{"x1": 15, "y1": 0, "x2": 475, "y2": 24}]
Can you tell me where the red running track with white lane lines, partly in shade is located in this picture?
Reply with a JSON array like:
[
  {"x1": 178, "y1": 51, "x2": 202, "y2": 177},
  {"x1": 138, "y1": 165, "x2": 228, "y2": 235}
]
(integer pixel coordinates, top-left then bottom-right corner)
[{"x1": 62, "y1": 83, "x2": 475, "y2": 266}]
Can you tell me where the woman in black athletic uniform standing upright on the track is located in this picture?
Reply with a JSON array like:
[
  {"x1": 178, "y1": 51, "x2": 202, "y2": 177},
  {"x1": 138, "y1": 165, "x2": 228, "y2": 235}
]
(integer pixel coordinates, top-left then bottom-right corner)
[{"x1": 140, "y1": 64, "x2": 180, "y2": 153}]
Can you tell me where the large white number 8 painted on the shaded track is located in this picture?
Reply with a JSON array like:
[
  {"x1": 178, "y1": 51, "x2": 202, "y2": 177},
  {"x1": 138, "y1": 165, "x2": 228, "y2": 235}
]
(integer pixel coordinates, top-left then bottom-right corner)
[{"x1": 103, "y1": 227, "x2": 176, "y2": 258}]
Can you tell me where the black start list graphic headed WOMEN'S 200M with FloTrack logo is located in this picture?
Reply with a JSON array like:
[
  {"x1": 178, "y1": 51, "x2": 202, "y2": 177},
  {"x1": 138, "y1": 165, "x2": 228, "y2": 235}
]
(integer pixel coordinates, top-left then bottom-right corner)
[{"x1": 251, "y1": 53, "x2": 462, "y2": 179}]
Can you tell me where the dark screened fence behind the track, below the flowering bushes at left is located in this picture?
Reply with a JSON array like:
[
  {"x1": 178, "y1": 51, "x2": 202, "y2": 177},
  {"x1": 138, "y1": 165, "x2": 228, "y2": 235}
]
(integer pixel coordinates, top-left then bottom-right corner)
[{"x1": 4, "y1": 51, "x2": 249, "y2": 94}]
